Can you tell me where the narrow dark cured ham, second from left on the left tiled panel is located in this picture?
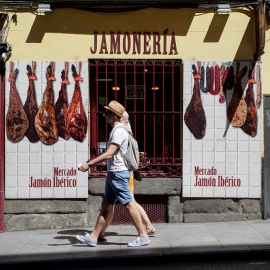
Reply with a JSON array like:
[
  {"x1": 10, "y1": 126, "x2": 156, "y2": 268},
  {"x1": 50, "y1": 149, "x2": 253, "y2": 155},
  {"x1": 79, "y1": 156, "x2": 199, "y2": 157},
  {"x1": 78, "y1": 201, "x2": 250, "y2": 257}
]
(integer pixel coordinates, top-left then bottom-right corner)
[{"x1": 23, "y1": 62, "x2": 40, "y2": 143}]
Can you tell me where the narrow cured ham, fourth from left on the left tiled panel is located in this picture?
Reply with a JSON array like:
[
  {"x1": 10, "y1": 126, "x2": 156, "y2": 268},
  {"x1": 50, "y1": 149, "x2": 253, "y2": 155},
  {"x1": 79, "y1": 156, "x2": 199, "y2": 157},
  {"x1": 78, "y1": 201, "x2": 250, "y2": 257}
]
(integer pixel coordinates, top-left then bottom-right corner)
[{"x1": 55, "y1": 62, "x2": 70, "y2": 140}]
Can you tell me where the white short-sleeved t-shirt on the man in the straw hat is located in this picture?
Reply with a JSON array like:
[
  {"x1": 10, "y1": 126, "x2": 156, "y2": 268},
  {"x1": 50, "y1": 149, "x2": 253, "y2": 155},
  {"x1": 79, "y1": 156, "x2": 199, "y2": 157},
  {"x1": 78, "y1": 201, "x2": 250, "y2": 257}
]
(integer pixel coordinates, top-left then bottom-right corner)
[{"x1": 107, "y1": 124, "x2": 128, "y2": 172}]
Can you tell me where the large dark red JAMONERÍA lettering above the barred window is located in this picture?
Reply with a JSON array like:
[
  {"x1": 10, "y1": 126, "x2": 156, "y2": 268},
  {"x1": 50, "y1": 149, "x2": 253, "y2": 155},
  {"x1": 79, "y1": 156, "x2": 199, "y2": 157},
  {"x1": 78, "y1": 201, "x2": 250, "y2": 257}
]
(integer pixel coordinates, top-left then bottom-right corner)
[{"x1": 90, "y1": 32, "x2": 178, "y2": 55}]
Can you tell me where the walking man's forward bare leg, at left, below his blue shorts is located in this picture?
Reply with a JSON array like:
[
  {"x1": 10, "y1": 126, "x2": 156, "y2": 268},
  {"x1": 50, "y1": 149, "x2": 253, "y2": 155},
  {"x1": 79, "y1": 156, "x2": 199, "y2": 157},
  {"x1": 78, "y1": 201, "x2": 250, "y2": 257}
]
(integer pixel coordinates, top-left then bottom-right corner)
[{"x1": 90, "y1": 203, "x2": 113, "y2": 239}]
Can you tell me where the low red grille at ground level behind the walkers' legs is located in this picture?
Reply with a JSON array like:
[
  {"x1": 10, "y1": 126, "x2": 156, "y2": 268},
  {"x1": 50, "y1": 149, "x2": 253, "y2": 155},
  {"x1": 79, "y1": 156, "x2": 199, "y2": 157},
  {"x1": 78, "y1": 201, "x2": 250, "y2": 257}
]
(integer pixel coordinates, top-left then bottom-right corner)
[{"x1": 111, "y1": 195, "x2": 167, "y2": 225}]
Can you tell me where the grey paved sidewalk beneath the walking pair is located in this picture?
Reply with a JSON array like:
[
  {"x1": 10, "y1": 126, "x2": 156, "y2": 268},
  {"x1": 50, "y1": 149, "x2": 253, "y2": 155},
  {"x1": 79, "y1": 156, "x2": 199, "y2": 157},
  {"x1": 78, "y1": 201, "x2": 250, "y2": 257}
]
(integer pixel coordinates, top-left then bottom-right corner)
[{"x1": 0, "y1": 220, "x2": 270, "y2": 265}]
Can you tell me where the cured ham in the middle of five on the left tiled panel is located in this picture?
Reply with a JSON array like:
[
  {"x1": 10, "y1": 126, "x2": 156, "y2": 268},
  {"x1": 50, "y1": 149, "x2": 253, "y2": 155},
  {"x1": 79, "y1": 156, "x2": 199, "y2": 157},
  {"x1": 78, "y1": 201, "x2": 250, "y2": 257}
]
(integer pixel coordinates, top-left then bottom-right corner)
[{"x1": 35, "y1": 62, "x2": 58, "y2": 145}]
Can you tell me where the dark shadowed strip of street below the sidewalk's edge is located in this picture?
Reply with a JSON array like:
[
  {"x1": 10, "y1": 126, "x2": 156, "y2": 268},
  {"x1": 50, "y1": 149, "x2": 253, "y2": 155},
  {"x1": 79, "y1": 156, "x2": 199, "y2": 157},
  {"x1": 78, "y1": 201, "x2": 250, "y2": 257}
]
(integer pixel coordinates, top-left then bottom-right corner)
[{"x1": 1, "y1": 252, "x2": 270, "y2": 270}]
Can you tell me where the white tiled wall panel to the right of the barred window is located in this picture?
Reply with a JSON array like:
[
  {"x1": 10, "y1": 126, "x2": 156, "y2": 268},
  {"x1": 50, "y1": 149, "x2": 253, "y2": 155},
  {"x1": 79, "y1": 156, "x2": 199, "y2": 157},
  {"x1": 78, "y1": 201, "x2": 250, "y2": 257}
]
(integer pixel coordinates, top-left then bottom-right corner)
[{"x1": 182, "y1": 61, "x2": 261, "y2": 198}]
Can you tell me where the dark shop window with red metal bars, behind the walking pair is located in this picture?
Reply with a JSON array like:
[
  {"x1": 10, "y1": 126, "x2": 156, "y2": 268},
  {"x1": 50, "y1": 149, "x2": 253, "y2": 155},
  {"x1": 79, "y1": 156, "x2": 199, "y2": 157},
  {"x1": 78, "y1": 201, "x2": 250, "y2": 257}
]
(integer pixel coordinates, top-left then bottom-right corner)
[{"x1": 89, "y1": 60, "x2": 182, "y2": 177}]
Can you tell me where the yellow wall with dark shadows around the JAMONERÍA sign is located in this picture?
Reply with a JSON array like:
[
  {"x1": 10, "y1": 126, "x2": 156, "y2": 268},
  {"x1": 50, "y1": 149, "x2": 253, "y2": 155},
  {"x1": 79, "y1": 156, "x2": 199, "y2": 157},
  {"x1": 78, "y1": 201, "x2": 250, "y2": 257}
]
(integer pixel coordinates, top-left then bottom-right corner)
[{"x1": 5, "y1": 8, "x2": 255, "y2": 61}]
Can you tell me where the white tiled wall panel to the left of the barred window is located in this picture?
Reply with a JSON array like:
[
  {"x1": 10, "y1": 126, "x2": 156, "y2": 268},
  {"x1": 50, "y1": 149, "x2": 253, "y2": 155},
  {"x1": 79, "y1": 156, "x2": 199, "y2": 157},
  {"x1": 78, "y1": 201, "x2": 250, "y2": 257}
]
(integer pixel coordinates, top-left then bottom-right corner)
[{"x1": 5, "y1": 61, "x2": 88, "y2": 199}]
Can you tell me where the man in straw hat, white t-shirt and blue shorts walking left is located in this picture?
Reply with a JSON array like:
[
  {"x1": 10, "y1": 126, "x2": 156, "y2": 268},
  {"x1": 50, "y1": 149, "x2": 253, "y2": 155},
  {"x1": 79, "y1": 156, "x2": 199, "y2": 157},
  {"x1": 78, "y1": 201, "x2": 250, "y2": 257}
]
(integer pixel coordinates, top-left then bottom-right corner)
[{"x1": 76, "y1": 100, "x2": 150, "y2": 247}]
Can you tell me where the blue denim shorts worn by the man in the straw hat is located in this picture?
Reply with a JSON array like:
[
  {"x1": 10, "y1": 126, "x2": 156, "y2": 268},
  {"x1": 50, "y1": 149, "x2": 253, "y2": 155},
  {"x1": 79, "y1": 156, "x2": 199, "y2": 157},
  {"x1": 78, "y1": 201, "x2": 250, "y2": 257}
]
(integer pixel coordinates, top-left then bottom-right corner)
[{"x1": 102, "y1": 171, "x2": 132, "y2": 205}]
